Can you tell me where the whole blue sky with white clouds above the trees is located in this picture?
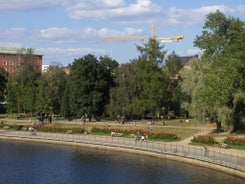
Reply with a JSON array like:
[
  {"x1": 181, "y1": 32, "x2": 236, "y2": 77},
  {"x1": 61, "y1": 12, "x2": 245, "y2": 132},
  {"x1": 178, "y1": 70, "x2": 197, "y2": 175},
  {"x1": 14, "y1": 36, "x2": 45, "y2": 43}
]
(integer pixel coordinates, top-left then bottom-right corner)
[{"x1": 0, "y1": 0, "x2": 245, "y2": 66}]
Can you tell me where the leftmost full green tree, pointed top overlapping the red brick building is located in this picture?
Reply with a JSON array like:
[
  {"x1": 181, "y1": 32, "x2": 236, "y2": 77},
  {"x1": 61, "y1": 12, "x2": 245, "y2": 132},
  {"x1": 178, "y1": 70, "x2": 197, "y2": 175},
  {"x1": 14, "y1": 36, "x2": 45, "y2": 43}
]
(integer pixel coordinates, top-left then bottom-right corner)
[{"x1": 7, "y1": 49, "x2": 41, "y2": 112}]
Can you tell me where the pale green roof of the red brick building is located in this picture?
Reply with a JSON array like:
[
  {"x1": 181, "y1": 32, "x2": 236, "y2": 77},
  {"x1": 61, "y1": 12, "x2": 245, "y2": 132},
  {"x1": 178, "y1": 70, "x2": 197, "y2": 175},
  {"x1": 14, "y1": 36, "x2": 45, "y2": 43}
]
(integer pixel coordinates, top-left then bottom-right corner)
[{"x1": 0, "y1": 47, "x2": 43, "y2": 56}]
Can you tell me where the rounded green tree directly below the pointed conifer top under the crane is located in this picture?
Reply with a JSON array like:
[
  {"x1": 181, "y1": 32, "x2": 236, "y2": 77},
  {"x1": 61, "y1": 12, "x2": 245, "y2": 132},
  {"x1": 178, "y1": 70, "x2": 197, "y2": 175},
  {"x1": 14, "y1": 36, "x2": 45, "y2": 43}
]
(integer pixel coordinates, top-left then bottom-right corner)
[{"x1": 130, "y1": 57, "x2": 164, "y2": 118}]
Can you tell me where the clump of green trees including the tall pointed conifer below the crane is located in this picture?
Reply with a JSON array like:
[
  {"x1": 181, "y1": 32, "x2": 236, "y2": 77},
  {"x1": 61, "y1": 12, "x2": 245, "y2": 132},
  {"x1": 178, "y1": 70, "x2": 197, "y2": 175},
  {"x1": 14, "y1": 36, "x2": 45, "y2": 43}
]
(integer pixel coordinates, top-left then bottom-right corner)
[{"x1": 108, "y1": 38, "x2": 166, "y2": 118}]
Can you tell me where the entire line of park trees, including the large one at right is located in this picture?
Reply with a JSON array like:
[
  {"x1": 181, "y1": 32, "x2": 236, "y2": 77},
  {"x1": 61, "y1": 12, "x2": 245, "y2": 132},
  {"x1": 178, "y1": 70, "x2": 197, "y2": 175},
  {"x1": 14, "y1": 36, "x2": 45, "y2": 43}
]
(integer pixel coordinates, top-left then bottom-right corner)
[{"x1": 0, "y1": 11, "x2": 245, "y2": 131}]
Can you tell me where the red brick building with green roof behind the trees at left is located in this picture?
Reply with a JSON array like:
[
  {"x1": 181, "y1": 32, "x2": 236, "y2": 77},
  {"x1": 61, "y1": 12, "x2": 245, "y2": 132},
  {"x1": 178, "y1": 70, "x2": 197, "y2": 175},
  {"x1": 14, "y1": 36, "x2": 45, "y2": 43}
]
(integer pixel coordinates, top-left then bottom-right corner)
[{"x1": 0, "y1": 46, "x2": 43, "y2": 74}]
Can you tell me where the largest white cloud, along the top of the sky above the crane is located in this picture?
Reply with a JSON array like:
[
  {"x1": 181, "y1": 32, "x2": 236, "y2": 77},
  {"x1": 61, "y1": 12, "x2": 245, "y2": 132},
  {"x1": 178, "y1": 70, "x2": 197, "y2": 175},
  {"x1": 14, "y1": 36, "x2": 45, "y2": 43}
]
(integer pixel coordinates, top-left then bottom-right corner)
[{"x1": 64, "y1": 0, "x2": 235, "y2": 26}]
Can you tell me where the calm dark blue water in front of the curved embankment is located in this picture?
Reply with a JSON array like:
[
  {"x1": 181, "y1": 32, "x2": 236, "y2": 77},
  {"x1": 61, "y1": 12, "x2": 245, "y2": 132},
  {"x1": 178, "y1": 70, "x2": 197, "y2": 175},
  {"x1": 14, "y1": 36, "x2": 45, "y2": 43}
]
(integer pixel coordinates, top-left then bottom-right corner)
[{"x1": 0, "y1": 141, "x2": 244, "y2": 184}]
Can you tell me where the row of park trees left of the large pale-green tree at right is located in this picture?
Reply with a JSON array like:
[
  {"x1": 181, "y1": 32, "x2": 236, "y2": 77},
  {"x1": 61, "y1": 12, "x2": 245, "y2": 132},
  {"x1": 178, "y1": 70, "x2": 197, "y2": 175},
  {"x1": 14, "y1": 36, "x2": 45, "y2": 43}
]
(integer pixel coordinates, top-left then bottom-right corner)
[{"x1": 2, "y1": 42, "x2": 182, "y2": 122}]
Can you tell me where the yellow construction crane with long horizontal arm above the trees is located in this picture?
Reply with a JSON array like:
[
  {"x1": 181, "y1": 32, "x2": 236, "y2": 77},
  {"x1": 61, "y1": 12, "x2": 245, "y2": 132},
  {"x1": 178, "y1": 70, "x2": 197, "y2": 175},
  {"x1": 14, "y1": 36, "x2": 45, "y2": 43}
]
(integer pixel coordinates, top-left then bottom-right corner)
[{"x1": 103, "y1": 26, "x2": 184, "y2": 41}]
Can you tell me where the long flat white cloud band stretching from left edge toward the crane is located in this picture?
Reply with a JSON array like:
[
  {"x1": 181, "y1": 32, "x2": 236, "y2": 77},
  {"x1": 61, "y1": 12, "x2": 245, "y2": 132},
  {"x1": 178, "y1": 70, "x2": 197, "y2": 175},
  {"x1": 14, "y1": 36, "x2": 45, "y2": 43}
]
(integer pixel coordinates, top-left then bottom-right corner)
[{"x1": 0, "y1": 27, "x2": 143, "y2": 44}]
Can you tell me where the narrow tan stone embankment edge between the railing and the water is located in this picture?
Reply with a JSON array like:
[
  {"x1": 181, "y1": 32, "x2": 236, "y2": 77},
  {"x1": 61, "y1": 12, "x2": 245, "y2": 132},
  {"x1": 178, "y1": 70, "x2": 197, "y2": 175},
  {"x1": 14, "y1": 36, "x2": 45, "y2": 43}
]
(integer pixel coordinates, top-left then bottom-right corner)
[{"x1": 0, "y1": 136, "x2": 245, "y2": 179}]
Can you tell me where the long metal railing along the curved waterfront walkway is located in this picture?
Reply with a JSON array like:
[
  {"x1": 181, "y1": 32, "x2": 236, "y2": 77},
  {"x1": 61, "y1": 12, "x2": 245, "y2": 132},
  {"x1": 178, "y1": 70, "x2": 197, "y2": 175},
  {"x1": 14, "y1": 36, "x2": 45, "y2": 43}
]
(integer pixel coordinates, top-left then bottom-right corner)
[{"x1": 0, "y1": 130, "x2": 245, "y2": 172}]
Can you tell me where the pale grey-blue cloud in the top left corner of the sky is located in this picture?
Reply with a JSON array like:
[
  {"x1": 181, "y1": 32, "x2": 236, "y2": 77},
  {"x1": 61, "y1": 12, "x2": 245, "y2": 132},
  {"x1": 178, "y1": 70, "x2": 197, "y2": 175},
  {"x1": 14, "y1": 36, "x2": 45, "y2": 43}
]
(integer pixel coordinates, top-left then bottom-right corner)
[{"x1": 0, "y1": 0, "x2": 60, "y2": 11}]
